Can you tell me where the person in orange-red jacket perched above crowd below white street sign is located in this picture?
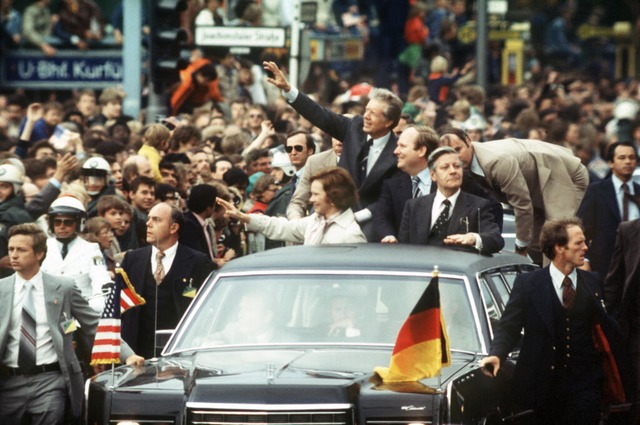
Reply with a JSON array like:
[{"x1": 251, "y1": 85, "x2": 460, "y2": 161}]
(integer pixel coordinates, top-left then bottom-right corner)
[{"x1": 171, "y1": 53, "x2": 223, "y2": 115}]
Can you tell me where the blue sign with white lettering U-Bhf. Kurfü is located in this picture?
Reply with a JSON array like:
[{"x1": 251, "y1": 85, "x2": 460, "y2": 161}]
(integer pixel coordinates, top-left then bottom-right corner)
[{"x1": 0, "y1": 50, "x2": 124, "y2": 89}]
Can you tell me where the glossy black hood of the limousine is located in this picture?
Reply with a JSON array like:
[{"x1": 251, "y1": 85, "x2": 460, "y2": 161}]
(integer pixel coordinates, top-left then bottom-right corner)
[{"x1": 103, "y1": 347, "x2": 475, "y2": 394}]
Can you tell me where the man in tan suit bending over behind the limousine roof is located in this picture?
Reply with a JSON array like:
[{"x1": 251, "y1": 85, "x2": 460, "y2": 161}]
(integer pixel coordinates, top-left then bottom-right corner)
[{"x1": 440, "y1": 129, "x2": 589, "y2": 265}]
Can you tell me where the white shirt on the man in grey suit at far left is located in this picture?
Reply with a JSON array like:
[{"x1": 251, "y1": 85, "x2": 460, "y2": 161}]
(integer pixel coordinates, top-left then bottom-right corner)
[{"x1": 2, "y1": 272, "x2": 57, "y2": 368}]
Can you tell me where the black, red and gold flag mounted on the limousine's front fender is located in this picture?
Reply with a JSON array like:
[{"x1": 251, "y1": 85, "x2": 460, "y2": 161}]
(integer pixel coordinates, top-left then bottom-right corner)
[{"x1": 374, "y1": 270, "x2": 451, "y2": 382}]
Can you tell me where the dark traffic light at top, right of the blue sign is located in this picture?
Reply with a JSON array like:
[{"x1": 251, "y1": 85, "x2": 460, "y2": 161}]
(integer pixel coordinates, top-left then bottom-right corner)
[{"x1": 147, "y1": 0, "x2": 189, "y2": 93}]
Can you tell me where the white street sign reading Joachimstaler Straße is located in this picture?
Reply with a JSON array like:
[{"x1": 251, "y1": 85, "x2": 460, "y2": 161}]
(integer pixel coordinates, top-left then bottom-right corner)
[{"x1": 195, "y1": 27, "x2": 286, "y2": 47}]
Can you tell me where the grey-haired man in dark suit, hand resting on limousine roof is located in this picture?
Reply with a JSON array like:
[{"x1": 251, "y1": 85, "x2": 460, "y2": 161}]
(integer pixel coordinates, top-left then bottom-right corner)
[{"x1": 398, "y1": 146, "x2": 504, "y2": 254}]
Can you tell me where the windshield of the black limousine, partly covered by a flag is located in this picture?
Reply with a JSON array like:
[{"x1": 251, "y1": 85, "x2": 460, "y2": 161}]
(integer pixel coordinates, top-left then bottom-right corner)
[{"x1": 171, "y1": 274, "x2": 480, "y2": 352}]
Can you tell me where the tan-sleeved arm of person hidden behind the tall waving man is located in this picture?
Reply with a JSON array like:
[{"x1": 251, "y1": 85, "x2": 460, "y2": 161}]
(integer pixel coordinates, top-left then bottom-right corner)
[{"x1": 287, "y1": 139, "x2": 342, "y2": 220}]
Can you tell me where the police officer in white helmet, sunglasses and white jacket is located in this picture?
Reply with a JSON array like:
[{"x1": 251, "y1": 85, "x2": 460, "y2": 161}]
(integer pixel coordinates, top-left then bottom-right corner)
[{"x1": 41, "y1": 195, "x2": 111, "y2": 312}]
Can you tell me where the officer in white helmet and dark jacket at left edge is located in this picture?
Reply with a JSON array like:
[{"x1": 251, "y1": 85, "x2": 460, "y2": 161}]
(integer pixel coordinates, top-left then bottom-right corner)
[{"x1": 0, "y1": 164, "x2": 33, "y2": 277}]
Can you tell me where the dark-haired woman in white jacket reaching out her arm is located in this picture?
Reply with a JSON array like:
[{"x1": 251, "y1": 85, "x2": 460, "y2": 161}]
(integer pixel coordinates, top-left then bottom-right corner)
[{"x1": 217, "y1": 167, "x2": 367, "y2": 245}]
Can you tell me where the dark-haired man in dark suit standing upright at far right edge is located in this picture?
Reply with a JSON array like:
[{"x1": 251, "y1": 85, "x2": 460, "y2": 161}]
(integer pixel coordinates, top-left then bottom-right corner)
[{"x1": 576, "y1": 142, "x2": 640, "y2": 276}]
